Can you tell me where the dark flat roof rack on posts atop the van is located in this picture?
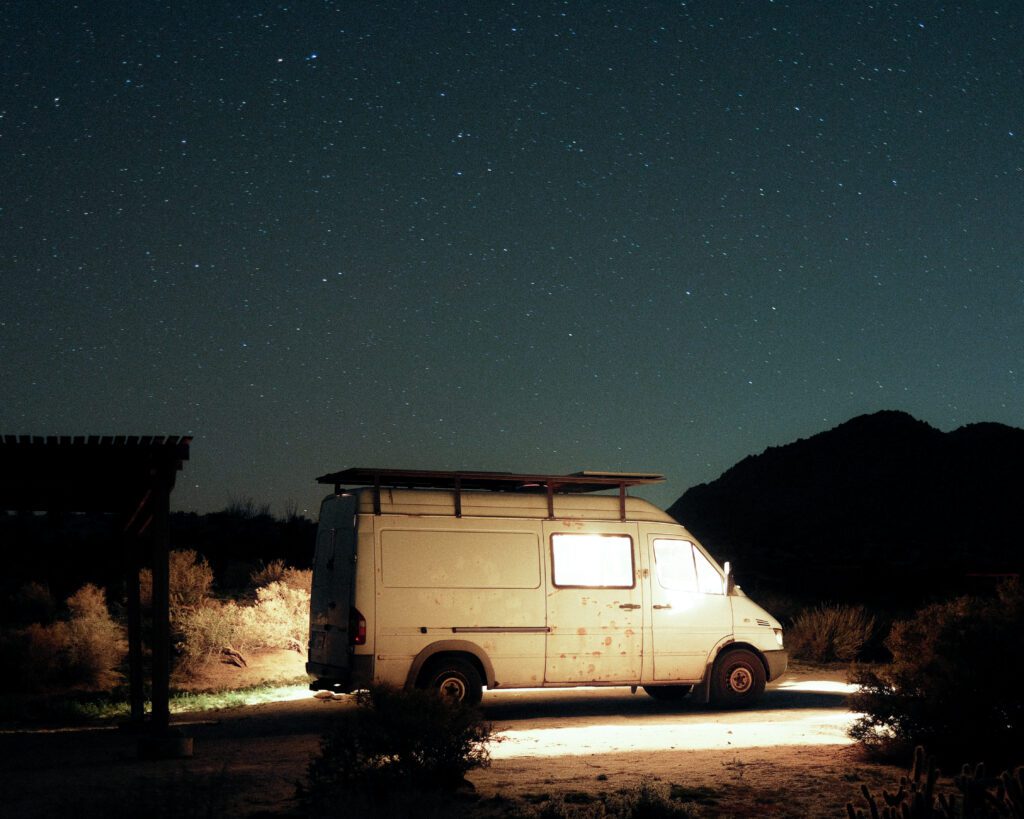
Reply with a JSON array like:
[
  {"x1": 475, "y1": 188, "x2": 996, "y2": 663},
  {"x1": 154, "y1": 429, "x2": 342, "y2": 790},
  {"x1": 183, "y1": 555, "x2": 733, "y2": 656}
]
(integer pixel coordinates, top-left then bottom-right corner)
[{"x1": 316, "y1": 467, "x2": 665, "y2": 520}]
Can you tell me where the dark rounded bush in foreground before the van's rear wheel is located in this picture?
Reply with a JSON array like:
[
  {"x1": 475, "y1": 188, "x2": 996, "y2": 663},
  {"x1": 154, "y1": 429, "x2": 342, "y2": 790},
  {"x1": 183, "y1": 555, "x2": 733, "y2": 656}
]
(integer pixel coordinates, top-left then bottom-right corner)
[{"x1": 300, "y1": 686, "x2": 492, "y2": 813}]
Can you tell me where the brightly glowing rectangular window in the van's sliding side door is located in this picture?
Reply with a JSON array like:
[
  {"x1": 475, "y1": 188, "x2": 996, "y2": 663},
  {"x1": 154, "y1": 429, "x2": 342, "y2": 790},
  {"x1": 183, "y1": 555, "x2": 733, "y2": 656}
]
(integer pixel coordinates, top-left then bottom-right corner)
[{"x1": 551, "y1": 534, "x2": 635, "y2": 589}]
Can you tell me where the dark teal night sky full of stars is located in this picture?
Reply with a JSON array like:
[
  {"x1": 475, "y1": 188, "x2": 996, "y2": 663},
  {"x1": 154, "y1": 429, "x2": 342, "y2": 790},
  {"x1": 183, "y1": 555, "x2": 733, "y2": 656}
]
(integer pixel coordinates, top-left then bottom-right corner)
[{"x1": 0, "y1": 0, "x2": 1024, "y2": 514}]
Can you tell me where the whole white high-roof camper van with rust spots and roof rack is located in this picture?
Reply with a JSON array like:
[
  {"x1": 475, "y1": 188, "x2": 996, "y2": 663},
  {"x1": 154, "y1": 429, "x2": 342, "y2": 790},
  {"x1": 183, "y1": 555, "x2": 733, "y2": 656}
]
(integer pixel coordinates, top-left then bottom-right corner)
[{"x1": 306, "y1": 469, "x2": 786, "y2": 706}]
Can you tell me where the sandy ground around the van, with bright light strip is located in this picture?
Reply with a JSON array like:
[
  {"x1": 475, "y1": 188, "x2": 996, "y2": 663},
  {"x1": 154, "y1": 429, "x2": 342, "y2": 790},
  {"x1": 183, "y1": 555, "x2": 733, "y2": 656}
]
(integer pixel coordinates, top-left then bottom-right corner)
[{"x1": 0, "y1": 657, "x2": 913, "y2": 817}]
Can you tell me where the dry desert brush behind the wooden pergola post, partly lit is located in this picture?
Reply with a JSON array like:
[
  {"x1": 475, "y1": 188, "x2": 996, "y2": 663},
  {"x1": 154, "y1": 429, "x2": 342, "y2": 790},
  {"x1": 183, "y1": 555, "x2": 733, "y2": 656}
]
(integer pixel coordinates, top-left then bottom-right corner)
[{"x1": 0, "y1": 549, "x2": 311, "y2": 717}]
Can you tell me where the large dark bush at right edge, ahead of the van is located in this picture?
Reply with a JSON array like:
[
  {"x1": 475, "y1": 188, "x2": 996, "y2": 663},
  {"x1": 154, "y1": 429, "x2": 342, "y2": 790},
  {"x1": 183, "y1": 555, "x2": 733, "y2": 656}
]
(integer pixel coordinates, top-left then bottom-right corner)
[{"x1": 850, "y1": 583, "x2": 1024, "y2": 762}]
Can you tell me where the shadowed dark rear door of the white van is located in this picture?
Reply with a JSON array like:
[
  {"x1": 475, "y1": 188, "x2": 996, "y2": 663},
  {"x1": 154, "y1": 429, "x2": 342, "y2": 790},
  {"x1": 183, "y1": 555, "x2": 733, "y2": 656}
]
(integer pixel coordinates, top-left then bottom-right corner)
[{"x1": 306, "y1": 494, "x2": 358, "y2": 688}]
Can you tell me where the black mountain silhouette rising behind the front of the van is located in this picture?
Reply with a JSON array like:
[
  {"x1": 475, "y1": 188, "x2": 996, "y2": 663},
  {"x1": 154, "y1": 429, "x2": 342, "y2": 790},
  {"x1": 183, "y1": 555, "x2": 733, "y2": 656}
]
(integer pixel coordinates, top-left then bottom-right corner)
[{"x1": 669, "y1": 411, "x2": 1024, "y2": 608}]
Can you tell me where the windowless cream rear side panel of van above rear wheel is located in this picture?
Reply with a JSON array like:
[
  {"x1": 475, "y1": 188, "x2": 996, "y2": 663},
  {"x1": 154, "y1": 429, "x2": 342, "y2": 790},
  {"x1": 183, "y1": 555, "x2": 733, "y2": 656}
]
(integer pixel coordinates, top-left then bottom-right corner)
[{"x1": 360, "y1": 515, "x2": 547, "y2": 687}]
